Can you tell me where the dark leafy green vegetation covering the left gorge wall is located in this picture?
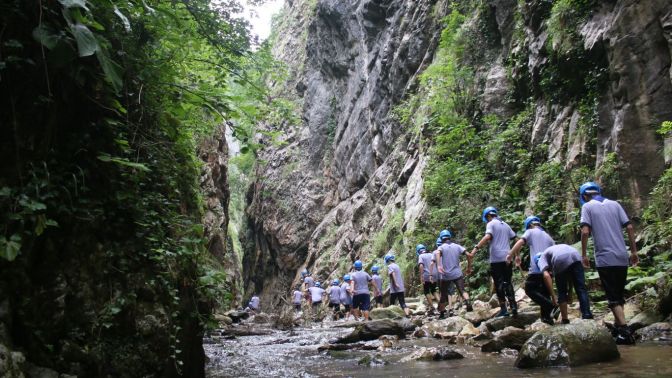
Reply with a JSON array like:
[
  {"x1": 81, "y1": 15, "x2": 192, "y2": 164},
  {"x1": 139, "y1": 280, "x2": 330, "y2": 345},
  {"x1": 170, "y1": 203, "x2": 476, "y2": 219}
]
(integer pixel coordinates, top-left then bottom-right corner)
[{"x1": 0, "y1": 0, "x2": 258, "y2": 376}]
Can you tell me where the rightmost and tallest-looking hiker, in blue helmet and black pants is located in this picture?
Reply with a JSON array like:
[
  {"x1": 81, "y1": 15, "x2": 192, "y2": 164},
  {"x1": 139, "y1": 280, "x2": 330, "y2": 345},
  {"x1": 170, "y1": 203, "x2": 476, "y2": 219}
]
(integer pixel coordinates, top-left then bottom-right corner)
[{"x1": 579, "y1": 182, "x2": 639, "y2": 344}]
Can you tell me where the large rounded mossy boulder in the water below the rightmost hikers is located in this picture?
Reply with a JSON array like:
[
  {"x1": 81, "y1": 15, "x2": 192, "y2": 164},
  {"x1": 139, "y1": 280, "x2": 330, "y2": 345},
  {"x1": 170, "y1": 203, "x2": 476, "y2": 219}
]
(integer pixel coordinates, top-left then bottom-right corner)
[{"x1": 516, "y1": 320, "x2": 620, "y2": 368}]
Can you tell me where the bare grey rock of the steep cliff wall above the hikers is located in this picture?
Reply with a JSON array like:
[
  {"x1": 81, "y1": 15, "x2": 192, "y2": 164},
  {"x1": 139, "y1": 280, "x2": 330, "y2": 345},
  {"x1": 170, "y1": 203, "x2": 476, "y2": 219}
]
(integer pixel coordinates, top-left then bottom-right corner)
[{"x1": 243, "y1": 0, "x2": 672, "y2": 304}]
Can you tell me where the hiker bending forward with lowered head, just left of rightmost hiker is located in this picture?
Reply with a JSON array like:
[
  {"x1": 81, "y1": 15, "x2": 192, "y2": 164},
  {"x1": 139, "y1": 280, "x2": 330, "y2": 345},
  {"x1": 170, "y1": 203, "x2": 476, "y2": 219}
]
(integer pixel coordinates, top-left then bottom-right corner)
[{"x1": 537, "y1": 244, "x2": 593, "y2": 324}]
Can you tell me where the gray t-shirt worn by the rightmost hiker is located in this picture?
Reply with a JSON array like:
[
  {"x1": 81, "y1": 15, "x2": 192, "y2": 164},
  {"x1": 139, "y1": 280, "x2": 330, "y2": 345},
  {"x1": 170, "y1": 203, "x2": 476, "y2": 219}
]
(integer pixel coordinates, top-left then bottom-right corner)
[{"x1": 581, "y1": 198, "x2": 630, "y2": 267}]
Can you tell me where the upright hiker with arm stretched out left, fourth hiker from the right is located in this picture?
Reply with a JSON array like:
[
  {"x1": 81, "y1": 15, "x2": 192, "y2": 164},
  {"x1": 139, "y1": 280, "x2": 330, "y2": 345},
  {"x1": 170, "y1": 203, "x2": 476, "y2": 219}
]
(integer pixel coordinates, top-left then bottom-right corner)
[{"x1": 467, "y1": 206, "x2": 518, "y2": 317}]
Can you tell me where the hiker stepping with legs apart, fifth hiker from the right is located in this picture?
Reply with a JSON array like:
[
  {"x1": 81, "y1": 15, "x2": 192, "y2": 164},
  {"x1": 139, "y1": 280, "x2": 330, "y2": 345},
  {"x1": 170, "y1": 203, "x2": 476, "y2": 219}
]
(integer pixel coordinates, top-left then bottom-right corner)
[{"x1": 434, "y1": 230, "x2": 473, "y2": 319}]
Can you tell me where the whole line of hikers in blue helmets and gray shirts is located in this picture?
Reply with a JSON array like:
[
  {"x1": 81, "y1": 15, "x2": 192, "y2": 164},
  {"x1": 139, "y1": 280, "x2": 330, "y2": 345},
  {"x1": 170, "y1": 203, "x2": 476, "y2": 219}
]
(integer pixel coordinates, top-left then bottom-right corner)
[{"x1": 292, "y1": 182, "x2": 638, "y2": 344}]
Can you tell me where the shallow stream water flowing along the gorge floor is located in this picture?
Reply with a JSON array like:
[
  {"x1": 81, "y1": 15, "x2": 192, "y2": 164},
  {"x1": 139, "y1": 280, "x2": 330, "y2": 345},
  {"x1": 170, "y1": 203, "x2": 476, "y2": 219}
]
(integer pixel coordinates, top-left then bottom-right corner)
[{"x1": 204, "y1": 323, "x2": 672, "y2": 378}]
